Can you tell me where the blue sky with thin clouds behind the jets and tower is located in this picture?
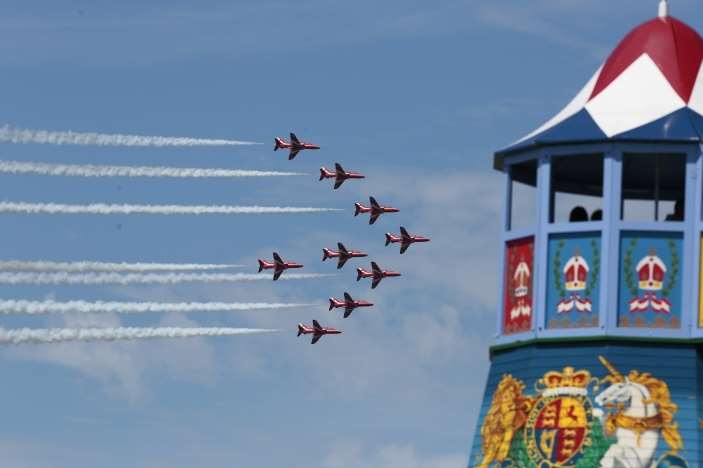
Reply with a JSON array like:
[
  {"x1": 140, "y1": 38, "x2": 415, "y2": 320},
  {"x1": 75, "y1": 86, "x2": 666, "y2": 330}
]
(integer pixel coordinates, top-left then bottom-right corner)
[{"x1": 0, "y1": 0, "x2": 703, "y2": 468}]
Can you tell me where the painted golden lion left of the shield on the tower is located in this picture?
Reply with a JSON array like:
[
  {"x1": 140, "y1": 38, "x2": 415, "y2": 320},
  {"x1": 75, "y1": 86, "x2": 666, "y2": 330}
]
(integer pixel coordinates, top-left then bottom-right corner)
[{"x1": 478, "y1": 374, "x2": 534, "y2": 468}]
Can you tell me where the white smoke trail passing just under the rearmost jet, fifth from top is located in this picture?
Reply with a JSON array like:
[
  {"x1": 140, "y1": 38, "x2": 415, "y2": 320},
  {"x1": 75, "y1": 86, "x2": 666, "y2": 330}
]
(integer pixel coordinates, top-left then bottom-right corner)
[{"x1": 0, "y1": 272, "x2": 333, "y2": 285}]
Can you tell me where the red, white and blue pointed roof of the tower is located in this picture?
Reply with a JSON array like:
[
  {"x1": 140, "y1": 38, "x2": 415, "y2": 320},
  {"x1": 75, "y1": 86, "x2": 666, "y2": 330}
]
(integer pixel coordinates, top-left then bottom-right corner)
[{"x1": 496, "y1": 10, "x2": 703, "y2": 166}]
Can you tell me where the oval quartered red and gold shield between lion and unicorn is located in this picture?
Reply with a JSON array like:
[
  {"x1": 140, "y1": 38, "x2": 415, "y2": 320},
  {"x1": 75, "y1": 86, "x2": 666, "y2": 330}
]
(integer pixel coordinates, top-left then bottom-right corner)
[{"x1": 525, "y1": 394, "x2": 593, "y2": 468}]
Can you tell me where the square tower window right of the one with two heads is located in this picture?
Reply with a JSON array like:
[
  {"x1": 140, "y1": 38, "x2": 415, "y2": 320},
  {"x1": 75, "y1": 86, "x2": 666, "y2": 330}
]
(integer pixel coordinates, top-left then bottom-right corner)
[{"x1": 621, "y1": 154, "x2": 686, "y2": 221}]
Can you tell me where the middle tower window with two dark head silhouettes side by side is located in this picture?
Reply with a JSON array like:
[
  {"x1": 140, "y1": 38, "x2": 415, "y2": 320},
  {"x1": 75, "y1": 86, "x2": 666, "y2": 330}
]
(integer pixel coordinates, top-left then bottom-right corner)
[{"x1": 549, "y1": 154, "x2": 603, "y2": 223}]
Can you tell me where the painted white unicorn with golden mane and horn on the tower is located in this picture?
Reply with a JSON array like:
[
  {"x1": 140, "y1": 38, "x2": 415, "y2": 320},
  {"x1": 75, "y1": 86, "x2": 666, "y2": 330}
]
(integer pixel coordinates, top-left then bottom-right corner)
[{"x1": 594, "y1": 356, "x2": 683, "y2": 468}]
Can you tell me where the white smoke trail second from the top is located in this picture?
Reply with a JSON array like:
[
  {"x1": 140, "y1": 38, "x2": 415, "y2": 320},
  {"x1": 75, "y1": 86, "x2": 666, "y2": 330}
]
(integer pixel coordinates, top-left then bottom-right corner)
[{"x1": 0, "y1": 161, "x2": 305, "y2": 178}]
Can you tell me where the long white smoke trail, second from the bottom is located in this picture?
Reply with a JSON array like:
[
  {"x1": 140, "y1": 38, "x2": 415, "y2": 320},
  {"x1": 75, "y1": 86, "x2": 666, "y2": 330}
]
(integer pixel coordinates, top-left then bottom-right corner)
[{"x1": 0, "y1": 300, "x2": 314, "y2": 315}]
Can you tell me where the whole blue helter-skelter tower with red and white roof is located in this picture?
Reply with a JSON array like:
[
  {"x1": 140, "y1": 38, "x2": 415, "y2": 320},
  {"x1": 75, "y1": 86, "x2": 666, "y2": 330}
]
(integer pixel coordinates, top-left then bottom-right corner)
[{"x1": 469, "y1": 0, "x2": 703, "y2": 468}]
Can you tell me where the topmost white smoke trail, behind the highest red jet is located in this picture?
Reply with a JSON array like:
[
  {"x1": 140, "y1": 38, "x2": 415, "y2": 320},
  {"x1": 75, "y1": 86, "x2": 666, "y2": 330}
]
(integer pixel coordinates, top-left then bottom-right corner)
[{"x1": 0, "y1": 125, "x2": 260, "y2": 146}]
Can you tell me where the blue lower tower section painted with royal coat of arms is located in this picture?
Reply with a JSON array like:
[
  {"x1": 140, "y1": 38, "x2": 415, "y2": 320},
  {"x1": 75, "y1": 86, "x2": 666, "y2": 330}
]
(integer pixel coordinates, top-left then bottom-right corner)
[{"x1": 468, "y1": 342, "x2": 703, "y2": 468}]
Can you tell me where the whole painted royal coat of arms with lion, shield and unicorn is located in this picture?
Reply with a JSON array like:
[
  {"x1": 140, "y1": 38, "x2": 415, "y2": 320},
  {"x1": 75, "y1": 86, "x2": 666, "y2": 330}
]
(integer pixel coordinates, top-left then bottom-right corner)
[{"x1": 475, "y1": 356, "x2": 688, "y2": 468}]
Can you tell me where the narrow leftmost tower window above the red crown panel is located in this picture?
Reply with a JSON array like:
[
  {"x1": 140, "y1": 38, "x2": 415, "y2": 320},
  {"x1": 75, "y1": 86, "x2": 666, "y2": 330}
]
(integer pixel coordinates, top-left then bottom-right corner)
[{"x1": 509, "y1": 159, "x2": 537, "y2": 230}]
